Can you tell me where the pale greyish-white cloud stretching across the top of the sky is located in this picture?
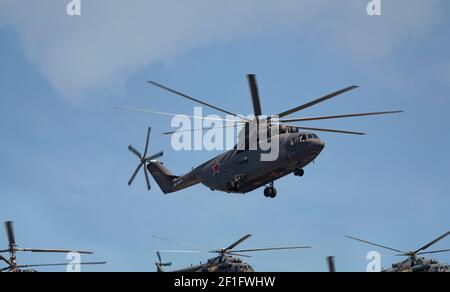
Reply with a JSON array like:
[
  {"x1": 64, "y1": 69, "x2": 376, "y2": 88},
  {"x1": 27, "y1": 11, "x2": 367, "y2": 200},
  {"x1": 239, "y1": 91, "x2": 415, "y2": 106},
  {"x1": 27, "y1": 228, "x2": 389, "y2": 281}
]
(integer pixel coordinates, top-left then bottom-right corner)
[{"x1": 0, "y1": 0, "x2": 440, "y2": 103}]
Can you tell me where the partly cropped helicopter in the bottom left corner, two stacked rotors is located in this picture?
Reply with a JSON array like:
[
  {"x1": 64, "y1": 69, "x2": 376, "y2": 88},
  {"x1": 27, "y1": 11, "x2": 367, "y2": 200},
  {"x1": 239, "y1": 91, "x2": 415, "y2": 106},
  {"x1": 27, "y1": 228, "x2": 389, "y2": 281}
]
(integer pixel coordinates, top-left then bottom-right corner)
[{"x1": 0, "y1": 221, "x2": 106, "y2": 273}]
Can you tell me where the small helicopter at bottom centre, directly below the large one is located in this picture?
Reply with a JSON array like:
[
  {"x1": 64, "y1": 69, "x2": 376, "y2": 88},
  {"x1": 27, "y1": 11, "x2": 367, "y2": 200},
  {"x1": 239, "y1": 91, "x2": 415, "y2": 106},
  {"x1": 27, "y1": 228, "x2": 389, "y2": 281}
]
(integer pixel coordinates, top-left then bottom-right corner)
[{"x1": 152, "y1": 234, "x2": 311, "y2": 273}]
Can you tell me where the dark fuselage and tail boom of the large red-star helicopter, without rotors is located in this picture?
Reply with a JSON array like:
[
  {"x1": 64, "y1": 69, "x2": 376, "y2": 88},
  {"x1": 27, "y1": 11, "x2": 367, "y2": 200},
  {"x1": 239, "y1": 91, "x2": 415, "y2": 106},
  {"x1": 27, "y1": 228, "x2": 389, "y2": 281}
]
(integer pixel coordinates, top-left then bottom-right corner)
[{"x1": 147, "y1": 131, "x2": 325, "y2": 194}]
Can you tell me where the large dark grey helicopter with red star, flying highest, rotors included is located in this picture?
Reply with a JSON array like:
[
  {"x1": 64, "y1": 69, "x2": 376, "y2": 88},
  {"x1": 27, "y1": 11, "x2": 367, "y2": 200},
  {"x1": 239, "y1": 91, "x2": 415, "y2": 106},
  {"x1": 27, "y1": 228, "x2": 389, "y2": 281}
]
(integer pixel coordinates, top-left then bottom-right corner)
[{"x1": 121, "y1": 74, "x2": 403, "y2": 198}]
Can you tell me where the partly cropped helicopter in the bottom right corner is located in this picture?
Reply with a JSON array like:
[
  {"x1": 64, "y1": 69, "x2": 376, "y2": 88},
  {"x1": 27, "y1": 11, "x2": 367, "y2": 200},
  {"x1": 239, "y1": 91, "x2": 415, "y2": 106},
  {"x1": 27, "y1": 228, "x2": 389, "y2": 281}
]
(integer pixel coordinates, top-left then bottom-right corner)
[{"x1": 346, "y1": 231, "x2": 450, "y2": 273}]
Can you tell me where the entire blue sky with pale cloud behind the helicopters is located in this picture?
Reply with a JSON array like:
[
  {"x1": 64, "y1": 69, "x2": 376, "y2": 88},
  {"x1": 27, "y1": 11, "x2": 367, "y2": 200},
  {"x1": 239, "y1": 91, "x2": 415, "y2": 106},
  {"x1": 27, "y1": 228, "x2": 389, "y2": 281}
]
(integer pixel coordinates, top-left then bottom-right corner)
[{"x1": 0, "y1": 0, "x2": 450, "y2": 271}]
